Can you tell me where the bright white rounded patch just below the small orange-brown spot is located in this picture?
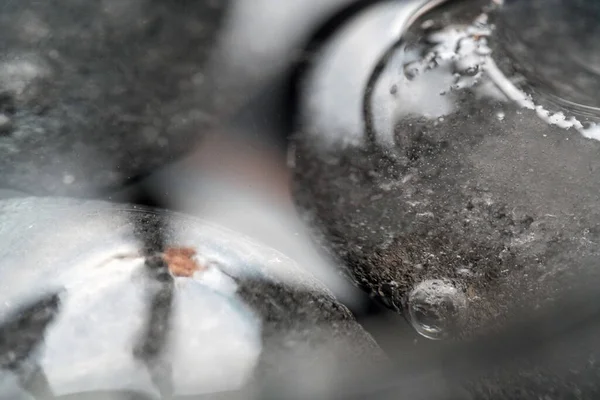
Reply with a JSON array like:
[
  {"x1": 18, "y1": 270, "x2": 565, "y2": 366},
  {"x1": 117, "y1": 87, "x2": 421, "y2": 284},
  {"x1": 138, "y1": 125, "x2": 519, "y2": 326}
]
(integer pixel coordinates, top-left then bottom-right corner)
[{"x1": 169, "y1": 270, "x2": 261, "y2": 395}]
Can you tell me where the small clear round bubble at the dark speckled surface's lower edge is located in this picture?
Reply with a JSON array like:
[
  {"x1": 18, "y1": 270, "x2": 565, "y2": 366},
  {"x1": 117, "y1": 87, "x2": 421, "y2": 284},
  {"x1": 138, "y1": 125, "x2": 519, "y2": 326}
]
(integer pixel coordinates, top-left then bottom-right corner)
[{"x1": 408, "y1": 279, "x2": 467, "y2": 340}]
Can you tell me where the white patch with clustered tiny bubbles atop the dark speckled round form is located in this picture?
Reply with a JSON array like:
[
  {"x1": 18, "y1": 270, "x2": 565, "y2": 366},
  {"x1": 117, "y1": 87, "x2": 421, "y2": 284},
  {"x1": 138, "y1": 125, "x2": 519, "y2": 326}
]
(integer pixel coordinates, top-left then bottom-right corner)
[{"x1": 371, "y1": 14, "x2": 492, "y2": 134}]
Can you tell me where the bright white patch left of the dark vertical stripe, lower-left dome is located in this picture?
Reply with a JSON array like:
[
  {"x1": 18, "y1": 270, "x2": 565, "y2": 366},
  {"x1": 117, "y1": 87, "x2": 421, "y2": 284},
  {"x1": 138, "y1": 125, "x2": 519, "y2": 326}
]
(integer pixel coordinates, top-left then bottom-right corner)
[{"x1": 41, "y1": 258, "x2": 157, "y2": 395}]
